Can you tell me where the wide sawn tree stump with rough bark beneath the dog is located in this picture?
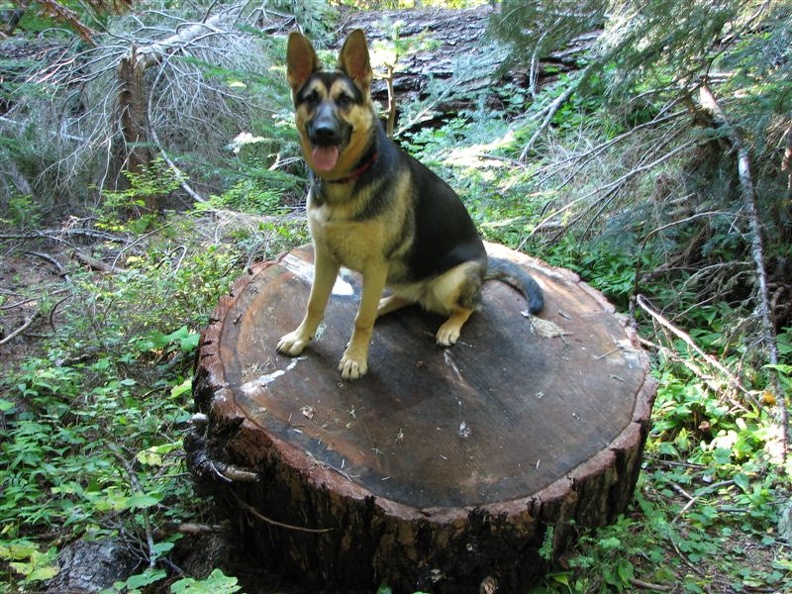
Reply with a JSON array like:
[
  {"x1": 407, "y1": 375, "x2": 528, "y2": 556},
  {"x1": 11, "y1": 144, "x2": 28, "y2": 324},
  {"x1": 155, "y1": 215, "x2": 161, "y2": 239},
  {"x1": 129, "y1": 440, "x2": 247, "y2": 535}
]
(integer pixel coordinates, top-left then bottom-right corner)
[{"x1": 186, "y1": 245, "x2": 656, "y2": 593}]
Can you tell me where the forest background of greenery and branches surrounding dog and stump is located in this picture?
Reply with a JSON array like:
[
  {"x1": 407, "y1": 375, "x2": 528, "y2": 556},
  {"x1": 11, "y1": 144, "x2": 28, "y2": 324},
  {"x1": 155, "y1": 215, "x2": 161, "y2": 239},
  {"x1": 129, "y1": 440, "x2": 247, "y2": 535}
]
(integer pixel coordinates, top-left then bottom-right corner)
[{"x1": 0, "y1": 0, "x2": 792, "y2": 593}]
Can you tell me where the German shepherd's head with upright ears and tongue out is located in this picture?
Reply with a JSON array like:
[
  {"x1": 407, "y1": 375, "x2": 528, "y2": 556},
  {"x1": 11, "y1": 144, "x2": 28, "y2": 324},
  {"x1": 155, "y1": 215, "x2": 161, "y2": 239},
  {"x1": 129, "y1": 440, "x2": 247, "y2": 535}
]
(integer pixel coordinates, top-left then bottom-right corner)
[{"x1": 286, "y1": 29, "x2": 376, "y2": 179}]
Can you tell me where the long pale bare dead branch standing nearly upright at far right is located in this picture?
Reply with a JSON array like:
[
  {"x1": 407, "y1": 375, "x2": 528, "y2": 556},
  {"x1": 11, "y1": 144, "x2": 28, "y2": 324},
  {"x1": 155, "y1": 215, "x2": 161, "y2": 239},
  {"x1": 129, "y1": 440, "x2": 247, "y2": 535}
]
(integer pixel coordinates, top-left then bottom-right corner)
[{"x1": 699, "y1": 80, "x2": 789, "y2": 461}]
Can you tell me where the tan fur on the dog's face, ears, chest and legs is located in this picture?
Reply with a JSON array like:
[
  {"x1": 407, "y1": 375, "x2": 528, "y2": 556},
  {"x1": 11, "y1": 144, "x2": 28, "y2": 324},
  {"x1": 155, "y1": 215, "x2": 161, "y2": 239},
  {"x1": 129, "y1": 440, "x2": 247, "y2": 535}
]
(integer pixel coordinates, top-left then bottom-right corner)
[{"x1": 277, "y1": 31, "x2": 486, "y2": 379}]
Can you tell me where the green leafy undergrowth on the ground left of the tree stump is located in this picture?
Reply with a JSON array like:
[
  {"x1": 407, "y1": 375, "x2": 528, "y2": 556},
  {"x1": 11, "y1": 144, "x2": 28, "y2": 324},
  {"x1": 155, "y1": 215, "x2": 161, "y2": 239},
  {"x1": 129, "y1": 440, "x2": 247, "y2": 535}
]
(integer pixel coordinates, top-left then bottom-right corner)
[{"x1": 0, "y1": 197, "x2": 304, "y2": 593}]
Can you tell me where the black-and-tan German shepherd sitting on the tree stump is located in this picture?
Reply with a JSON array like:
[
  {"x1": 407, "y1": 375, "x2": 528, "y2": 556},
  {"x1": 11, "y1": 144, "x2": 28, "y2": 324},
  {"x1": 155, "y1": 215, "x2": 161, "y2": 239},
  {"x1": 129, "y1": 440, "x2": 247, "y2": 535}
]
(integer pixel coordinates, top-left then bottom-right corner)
[{"x1": 277, "y1": 29, "x2": 543, "y2": 379}]
